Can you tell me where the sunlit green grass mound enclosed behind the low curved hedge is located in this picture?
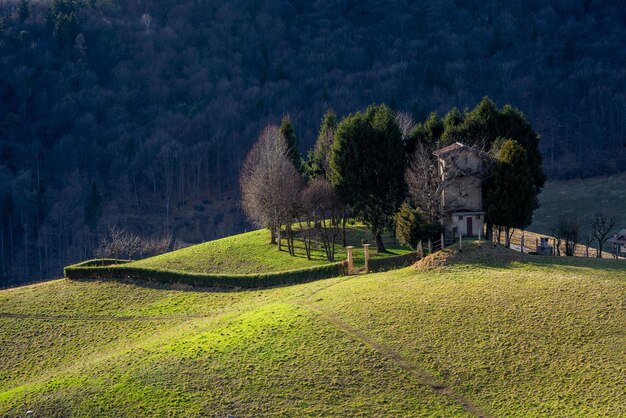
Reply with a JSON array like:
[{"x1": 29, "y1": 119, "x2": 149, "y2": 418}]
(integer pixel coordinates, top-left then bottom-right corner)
[{"x1": 127, "y1": 225, "x2": 410, "y2": 274}]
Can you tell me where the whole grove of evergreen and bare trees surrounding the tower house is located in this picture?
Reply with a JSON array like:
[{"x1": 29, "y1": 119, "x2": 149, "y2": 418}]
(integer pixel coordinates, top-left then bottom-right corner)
[{"x1": 240, "y1": 97, "x2": 545, "y2": 255}]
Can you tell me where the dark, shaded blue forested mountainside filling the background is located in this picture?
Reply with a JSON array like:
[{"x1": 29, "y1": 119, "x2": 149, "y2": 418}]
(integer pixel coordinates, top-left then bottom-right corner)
[{"x1": 0, "y1": 0, "x2": 626, "y2": 285}]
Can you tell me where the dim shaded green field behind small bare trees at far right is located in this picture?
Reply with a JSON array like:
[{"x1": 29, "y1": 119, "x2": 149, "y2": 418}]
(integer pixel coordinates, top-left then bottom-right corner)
[{"x1": 528, "y1": 173, "x2": 626, "y2": 234}]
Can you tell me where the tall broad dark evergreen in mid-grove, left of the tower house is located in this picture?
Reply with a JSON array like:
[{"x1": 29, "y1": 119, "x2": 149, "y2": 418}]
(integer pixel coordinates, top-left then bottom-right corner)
[{"x1": 330, "y1": 105, "x2": 405, "y2": 252}]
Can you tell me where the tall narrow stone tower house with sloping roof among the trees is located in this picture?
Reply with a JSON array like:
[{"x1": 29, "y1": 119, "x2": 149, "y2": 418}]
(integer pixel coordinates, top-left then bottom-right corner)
[{"x1": 434, "y1": 142, "x2": 485, "y2": 242}]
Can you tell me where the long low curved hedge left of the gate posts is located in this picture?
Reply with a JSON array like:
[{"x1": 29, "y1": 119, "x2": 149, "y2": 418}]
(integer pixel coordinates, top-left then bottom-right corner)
[{"x1": 64, "y1": 260, "x2": 347, "y2": 289}]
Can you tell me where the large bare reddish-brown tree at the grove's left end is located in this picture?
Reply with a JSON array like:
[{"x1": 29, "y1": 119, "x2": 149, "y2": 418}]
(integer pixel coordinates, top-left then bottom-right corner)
[{"x1": 240, "y1": 125, "x2": 303, "y2": 252}]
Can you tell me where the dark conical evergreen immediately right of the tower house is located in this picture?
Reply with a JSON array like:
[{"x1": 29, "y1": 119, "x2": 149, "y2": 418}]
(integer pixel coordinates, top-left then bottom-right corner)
[{"x1": 485, "y1": 139, "x2": 539, "y2": 247}]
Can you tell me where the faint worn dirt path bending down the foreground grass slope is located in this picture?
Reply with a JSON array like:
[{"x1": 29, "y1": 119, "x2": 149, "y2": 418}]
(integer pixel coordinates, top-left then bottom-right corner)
[{"x1": 295, "y1": 276, "x2": 489, "y2": 418}]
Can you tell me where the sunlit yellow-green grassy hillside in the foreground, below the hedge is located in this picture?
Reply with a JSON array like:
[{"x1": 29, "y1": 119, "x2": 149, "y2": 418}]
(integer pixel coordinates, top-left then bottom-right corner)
[{"x1": 0, "y1": 245, "x2": 626, "y2": 416}]
